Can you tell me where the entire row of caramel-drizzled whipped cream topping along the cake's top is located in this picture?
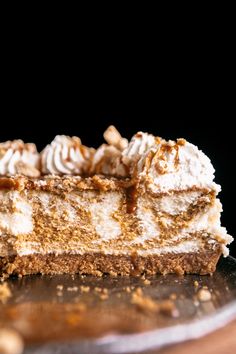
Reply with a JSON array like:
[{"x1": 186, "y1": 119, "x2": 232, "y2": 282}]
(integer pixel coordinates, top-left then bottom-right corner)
[{"x1": 0, "y1": 126, "x2": 220, "y2": 193}]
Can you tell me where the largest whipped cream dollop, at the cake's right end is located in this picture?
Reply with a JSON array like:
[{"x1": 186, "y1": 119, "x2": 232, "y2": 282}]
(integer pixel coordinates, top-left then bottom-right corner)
[{"x1": 138, "y1": 139, "x2": 219, "y2": 192}]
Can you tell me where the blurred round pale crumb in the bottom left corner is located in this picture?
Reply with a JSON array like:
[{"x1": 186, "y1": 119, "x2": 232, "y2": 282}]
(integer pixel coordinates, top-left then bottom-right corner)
[{"x1": 0, "y1": 328, "x2": 24, "y2": 354}]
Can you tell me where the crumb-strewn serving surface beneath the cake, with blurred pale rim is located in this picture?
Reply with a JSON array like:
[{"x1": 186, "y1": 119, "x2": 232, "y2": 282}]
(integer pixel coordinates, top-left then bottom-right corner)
[{"x1": 0, "y1": 257, "x2": 236, "y2": 354}]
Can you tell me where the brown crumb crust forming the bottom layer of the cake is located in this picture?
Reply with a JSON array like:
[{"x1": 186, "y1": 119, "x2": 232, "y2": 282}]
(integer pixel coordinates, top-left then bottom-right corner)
[{"x1": 0, "y1": 248, "x2": 222, "y2": 276}]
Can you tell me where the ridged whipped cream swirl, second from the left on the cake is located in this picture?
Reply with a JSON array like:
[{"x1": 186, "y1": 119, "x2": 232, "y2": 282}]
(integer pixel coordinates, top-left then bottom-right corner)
[{"x1": 41, "y1": 135, "x2": 93, "y2": 175}]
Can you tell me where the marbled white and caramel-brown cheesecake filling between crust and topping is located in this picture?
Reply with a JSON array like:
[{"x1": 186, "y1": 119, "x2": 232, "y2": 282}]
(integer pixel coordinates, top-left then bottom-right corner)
[{"x1": 0, "y1": 190, "x2": 232, "y2": 256}]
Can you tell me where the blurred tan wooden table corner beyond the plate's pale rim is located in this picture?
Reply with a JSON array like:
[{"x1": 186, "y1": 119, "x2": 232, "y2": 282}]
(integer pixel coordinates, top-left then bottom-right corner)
[{"x1": 147, "y1": 321, "x2": 236, "y2": 354}]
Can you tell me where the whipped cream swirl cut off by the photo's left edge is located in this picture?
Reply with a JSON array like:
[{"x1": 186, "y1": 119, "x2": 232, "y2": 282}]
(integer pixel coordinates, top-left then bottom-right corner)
[{"x1": 0, "y1": 140, "x2": 40, "y2": 177}]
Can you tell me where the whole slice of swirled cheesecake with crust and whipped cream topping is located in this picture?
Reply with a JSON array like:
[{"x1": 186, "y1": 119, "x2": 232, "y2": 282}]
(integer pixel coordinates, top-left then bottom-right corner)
[{"x1": 0, "y1": 126, "x2": 232, "y2": 276}]
